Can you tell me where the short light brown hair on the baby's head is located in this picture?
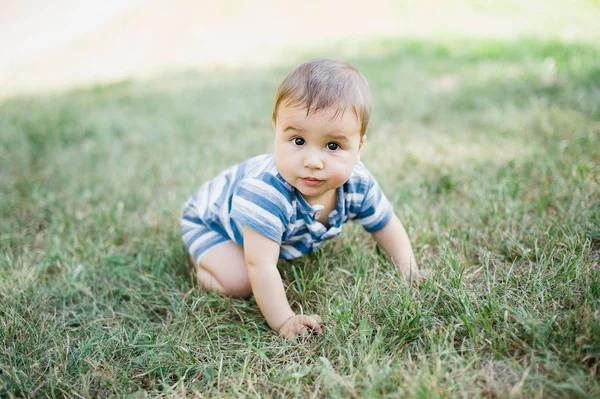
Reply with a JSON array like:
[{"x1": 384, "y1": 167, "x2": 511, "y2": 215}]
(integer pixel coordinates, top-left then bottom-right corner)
[{"x1": 273, "y1": 58, "x2": 372, "y2": 136}]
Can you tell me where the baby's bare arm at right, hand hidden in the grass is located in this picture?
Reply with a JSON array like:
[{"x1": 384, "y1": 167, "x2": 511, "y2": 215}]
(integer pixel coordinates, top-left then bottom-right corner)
[{"x1": 373, "y1": 214, "x2": 422, "y2": 282}]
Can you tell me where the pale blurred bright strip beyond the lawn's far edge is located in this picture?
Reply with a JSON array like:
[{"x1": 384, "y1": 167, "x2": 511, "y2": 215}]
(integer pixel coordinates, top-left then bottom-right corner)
[{"x1": 0, "y1": 0, "x2": 600, "y2": 94}]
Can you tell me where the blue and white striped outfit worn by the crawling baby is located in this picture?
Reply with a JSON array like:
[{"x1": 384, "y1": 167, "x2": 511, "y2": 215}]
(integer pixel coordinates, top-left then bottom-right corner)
[{"x1": 182, "y1": 154, "x2": 393, "y2": 260}]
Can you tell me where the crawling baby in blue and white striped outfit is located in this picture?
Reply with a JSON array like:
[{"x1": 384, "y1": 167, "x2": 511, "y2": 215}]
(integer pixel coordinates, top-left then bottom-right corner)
[{"x1": 181, "y1": 58, "x2": 421, "y2": 340}]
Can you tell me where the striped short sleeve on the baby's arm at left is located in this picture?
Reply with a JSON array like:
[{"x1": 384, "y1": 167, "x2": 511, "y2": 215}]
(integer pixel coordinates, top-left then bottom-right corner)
[{"x1": 230, "y1": 177, "x2": 291, "y2": 244}]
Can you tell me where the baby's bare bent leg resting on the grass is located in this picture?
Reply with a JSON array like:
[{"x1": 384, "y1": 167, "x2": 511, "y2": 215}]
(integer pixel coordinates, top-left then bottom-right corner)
[{"x1": 192, "y1": 241, "x2": 252, "y2": 298}]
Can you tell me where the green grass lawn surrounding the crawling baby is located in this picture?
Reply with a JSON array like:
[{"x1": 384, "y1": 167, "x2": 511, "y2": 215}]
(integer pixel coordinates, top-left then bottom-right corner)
[{"x1": 0, "y1": 38, "x2": 600, "y2": 398}]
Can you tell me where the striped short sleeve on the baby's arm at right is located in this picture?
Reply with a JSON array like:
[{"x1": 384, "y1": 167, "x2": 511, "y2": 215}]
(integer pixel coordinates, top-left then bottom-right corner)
[{"x1": 354, "y1": 173, "x2": 394, "y2": 233}]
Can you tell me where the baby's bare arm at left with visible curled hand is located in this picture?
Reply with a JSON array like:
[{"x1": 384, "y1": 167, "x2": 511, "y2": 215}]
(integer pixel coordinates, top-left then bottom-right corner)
[{"x1": 244, "y1": 227, "x2": 321, "y2": 340}]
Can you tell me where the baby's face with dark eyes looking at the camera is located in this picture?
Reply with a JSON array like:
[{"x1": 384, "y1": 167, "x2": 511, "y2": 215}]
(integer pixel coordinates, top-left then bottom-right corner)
[{"x1": 273, "y1": 106, "x2": 363, "y2": 204}]
